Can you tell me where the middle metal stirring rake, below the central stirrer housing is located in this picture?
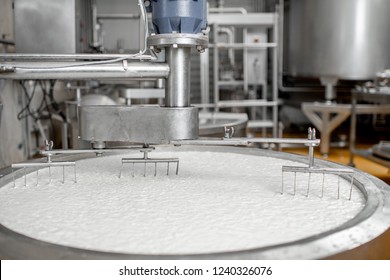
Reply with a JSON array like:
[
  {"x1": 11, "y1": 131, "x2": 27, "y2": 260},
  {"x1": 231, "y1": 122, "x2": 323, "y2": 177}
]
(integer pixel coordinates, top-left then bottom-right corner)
[{"x1": 119, "y1": 146, "x2": 179, "y2": 178}]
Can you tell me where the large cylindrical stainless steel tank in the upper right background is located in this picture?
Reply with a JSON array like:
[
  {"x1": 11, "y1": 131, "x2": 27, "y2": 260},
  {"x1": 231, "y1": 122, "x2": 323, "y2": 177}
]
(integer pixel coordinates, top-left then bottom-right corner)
[{"x1": 286, "y1": 0, "x2": 390, "y2": 80}]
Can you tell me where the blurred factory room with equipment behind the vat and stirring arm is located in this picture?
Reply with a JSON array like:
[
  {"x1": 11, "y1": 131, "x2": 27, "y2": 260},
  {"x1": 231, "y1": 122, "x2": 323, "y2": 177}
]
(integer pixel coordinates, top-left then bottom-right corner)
[{"x1": 0, "y1": 0, "x2": 390, "y2": 179}]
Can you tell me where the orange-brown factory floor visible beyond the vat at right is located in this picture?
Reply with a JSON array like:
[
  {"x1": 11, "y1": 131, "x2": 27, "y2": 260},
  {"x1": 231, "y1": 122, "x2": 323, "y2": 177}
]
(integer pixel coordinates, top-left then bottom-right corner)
[{"x1": 283, "y1": 144, "x2": 390, "y2": 260}]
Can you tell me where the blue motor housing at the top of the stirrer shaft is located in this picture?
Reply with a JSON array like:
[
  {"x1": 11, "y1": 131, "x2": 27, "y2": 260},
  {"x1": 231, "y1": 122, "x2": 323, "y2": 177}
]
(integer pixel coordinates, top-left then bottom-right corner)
[{"x1": 151, "y1": 0, "x2": 207, "y2": 34}]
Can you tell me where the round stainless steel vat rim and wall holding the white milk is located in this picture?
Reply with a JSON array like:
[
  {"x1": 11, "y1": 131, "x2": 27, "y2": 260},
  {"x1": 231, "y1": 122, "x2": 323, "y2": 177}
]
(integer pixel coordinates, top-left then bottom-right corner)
[{"x1": 0, "y1": 146, "x2": 390, "y2": 259}]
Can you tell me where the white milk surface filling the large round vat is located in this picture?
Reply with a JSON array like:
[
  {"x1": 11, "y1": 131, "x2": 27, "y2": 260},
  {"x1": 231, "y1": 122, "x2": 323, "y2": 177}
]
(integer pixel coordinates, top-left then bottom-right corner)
[{"x1": 0, "y1": 152, "x2": 364, "y2": 254}]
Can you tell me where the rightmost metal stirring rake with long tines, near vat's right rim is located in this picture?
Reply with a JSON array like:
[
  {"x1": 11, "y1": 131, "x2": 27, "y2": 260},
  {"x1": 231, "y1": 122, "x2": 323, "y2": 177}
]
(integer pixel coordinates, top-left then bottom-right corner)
[{"x1": 281, "y1": 128, "x2": 354, "y2": 200}]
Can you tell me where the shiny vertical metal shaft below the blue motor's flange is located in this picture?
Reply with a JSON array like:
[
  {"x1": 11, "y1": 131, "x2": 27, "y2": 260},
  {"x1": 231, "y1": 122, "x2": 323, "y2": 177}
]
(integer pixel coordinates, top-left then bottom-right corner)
[{"x1": 165, "y1": 46, "x2": 191, "y2": 107}]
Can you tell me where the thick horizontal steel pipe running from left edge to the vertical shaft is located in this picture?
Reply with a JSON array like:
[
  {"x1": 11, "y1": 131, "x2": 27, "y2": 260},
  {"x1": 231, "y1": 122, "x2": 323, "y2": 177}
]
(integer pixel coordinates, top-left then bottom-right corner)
[{"x1": 0, "y1": 60, "x2": 169, "y2": 80}]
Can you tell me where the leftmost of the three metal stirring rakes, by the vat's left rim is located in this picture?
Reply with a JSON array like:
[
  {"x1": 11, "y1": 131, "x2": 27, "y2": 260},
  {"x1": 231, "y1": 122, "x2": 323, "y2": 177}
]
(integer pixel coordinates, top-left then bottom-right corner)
[{"x1": 11, "y1": 140, "x2": 77, "y2": 187}]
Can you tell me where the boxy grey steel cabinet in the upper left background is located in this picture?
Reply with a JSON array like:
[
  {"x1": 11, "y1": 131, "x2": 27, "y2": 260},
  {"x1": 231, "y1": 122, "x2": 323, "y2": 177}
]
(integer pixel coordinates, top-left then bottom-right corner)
[{"x1": 13, "y1": 0, "x2": 91, "y2": 54}]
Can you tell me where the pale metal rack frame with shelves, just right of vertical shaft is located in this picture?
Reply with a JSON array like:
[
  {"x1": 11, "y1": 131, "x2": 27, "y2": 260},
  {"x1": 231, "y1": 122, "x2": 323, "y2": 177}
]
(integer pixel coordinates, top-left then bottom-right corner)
[{"x1": 209, "y1": 13, "x2": 279, "y2": 138}]
